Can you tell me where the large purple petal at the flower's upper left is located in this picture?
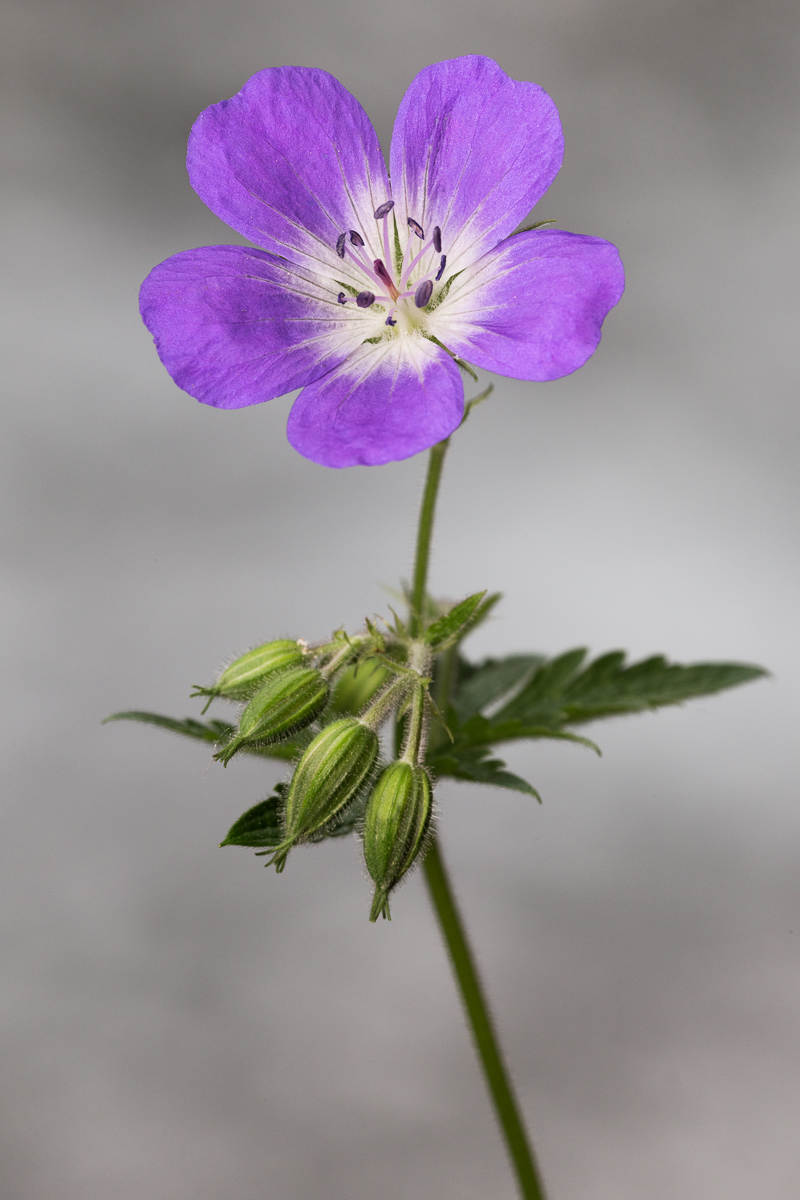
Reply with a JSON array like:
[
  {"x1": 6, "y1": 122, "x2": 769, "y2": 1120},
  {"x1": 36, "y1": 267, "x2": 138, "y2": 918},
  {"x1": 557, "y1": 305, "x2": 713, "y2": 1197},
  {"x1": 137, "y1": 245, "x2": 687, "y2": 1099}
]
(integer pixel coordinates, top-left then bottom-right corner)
[{"x1": 186, "y1": 67, "x2": 391, "y2": 278}]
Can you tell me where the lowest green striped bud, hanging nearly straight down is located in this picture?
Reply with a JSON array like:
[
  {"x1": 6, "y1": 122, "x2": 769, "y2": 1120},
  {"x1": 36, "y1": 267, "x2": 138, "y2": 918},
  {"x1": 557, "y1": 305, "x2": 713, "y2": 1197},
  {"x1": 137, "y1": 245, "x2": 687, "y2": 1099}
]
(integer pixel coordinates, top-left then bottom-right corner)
[{"x1": 363, "y1": 761, "x2": 433, "y2": 920}]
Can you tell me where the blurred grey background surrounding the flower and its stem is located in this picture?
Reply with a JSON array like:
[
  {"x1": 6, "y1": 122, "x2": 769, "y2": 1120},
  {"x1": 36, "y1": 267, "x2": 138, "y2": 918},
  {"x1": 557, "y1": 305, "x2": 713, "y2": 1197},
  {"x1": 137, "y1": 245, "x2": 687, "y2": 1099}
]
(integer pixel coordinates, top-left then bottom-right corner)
[{"x1": 0, "y1": 0, "x2": 800, "y2": 1200}]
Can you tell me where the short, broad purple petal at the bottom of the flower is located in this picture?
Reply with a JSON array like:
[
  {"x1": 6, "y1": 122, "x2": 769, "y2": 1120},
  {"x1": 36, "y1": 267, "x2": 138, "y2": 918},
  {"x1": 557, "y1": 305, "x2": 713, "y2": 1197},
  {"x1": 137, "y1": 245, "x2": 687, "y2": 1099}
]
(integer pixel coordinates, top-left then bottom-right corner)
[{"x1": 287, "y1": 337, "x2": 464, "y2": 467}]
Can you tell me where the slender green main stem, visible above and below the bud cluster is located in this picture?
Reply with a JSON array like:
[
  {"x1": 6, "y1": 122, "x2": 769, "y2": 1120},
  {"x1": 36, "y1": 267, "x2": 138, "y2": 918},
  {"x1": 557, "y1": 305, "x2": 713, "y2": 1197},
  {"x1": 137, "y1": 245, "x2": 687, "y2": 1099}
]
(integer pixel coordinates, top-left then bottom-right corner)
[{"x1": 410, "y1": 439, "x2": 545, "y2": 1200}]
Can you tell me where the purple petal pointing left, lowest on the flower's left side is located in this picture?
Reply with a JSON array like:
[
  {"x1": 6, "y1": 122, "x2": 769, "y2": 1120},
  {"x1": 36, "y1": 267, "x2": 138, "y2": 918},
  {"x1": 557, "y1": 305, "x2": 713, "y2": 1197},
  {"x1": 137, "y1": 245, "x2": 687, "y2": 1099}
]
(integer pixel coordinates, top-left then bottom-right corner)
[{"x1": 139, "y1": 246, "x2": 383, "y2": 408}]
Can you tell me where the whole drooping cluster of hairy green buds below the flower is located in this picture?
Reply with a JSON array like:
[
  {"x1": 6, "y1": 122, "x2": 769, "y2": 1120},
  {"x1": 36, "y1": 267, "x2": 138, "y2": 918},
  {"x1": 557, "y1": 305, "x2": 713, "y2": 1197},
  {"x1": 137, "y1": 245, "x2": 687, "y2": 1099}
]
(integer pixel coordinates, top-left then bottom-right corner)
[{"x1": 200, "y1": 593, "x2": 482, "y2": 920}]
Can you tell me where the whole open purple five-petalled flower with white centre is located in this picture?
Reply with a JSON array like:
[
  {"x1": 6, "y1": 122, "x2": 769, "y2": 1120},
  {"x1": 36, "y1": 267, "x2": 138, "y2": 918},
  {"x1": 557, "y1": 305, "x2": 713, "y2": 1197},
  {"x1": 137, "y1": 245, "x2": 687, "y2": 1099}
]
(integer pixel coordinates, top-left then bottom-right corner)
[{"x1": 140, "y1": 55, "x2": 622, "y2": 467}]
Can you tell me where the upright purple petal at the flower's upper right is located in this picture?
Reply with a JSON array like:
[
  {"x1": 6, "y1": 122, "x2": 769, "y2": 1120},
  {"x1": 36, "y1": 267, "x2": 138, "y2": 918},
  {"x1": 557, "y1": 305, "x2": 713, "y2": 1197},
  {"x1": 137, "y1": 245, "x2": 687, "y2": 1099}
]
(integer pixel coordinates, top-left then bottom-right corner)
[{"x1": 391, "y1": 54, "x2": 564, "y2": 272}]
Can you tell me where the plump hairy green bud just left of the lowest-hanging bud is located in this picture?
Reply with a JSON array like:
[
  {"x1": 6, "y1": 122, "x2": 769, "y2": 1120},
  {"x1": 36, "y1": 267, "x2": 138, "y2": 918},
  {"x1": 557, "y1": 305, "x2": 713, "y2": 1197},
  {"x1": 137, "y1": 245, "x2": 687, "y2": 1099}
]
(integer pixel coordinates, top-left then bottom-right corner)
[{"x1": 271, "y1": 716, "x2": 378, "y2": 871}]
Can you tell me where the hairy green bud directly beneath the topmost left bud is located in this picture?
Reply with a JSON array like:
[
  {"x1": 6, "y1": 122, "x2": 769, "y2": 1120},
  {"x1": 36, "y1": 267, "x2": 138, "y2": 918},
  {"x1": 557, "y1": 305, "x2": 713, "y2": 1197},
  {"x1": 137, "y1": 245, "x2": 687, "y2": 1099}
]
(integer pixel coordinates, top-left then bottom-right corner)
[{"x1": 213, "y1": 667, "x2": 329, "y2": 763}]
